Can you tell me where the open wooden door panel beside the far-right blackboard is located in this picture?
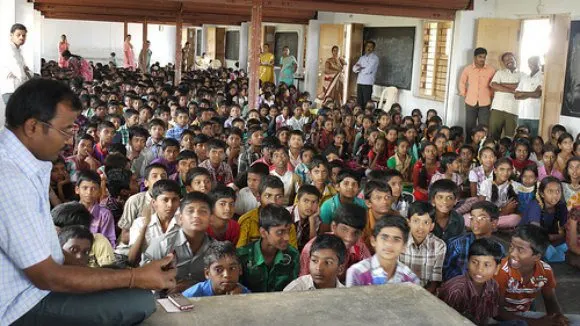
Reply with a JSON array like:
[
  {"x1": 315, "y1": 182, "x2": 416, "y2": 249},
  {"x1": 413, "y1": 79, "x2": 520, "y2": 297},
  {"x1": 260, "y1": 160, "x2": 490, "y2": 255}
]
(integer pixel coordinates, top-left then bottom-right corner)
[{"x1": 540, "y1": 14, "x2": 570, "y2": 139}]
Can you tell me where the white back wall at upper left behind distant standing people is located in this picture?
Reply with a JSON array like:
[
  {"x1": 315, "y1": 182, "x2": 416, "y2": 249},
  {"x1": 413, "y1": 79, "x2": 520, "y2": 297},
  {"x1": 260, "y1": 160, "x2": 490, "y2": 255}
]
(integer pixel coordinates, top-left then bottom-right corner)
[{"x1": 41, "y1": 18, "x2": 175, "y2": 65}]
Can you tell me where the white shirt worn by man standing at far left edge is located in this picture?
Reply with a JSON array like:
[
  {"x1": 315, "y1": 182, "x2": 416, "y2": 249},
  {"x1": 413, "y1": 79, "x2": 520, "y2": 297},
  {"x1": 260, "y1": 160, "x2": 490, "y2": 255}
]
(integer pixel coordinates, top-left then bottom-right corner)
[{"x1": 0, "y1": 41, "x2": 28, "y2": 94}]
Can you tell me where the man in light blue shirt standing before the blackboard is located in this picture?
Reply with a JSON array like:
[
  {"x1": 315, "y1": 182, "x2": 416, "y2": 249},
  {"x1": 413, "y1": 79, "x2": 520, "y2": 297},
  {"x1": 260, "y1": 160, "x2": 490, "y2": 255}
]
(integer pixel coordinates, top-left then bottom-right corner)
[{"x1": 352, "y1": 41, "x2": 379, "y2": 108}]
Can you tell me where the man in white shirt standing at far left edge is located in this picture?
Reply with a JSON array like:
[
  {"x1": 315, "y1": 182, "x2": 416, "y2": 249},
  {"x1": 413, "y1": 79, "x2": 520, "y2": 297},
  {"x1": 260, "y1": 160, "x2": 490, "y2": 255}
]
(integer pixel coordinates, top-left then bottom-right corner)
[{"x1": 0, "y1": 24, "x2": 31, "y2": 104}]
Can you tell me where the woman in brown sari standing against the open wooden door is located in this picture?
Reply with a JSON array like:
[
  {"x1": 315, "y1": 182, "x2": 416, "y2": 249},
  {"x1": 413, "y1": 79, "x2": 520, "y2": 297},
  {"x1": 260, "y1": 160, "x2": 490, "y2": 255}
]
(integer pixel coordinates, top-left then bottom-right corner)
[{"x1": 321, "y1": 45, "x2": 346, "y2": 105}]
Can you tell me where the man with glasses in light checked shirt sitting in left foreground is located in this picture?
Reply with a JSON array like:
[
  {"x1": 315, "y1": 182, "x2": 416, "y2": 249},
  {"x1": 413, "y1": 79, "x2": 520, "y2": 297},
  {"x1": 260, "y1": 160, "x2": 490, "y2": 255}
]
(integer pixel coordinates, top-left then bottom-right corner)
[{"x1": 0, "y1": 79, "x2": 176, "y2": 325}]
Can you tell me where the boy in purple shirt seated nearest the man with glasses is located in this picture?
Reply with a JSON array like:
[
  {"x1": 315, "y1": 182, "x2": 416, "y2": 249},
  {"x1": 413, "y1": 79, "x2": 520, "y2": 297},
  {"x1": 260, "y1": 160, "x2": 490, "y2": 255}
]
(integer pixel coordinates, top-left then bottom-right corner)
[{"x1": 75, "y1": 170, "x2": 117, "y2": 247}]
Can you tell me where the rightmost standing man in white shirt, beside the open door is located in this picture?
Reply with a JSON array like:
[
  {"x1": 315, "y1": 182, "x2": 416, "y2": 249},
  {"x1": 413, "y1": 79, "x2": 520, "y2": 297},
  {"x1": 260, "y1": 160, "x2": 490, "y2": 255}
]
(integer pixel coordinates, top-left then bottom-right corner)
[{"x1": 514, "y1": 56, "x2": 544, "y2": 137}]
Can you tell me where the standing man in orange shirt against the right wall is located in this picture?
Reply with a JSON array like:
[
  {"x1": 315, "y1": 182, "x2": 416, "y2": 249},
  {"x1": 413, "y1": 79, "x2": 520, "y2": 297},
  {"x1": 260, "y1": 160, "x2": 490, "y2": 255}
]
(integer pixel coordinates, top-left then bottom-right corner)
[{"x1": 459, "y1": 48, "x2": 495, "y2": 139}]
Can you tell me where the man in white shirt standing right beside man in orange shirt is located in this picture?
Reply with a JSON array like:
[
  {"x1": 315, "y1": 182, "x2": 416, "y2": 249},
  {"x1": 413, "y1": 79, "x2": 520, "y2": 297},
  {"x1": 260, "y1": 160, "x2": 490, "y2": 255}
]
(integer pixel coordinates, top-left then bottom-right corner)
[{"x1": 489, "y1": 52, "x2": 521, "y2": 139}]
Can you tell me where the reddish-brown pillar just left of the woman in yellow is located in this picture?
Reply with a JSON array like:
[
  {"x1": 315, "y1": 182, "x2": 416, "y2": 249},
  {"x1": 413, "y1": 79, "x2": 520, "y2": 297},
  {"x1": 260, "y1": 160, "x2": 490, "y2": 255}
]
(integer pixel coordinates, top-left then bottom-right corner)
[{"x1": 248, "y1": 0, "x2": 264, "y2": 109}]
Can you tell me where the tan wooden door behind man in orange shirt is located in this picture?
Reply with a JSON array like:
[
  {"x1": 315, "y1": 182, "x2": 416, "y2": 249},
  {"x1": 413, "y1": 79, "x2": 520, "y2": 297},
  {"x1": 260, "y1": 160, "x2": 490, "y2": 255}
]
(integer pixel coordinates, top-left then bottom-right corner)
[{"x1": 476, "y1": 18, "x2": 522, "y2": 70}]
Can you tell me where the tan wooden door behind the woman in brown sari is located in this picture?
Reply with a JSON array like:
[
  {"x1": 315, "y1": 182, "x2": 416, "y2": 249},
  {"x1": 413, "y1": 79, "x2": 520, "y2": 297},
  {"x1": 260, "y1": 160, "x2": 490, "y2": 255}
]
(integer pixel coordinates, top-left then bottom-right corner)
[{"x1": 316, "y1": 24, "x2": 345, "y2": 101}]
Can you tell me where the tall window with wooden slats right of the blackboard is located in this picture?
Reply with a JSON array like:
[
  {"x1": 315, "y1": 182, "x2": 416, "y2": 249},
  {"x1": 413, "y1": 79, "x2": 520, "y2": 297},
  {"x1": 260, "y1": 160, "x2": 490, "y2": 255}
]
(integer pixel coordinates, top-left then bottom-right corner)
[{"x1": 419, "y1": 21, "x2": 453, "y2": 102}]
